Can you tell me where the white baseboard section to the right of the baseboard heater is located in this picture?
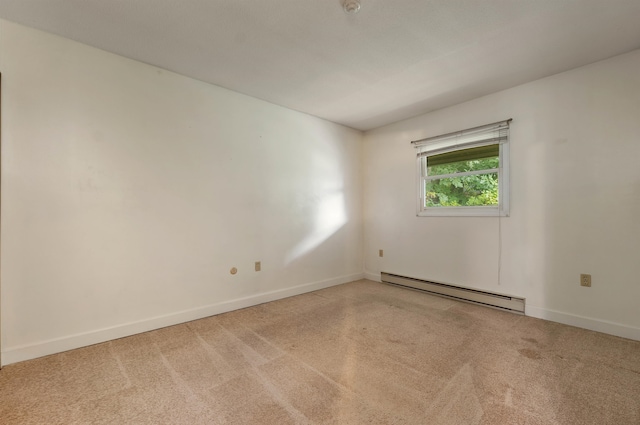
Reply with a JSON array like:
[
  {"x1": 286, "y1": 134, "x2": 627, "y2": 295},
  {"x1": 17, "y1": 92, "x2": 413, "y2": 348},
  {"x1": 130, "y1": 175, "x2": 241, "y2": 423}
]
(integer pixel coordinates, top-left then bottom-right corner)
[{"x1": 525, "y1": 305, "x2": 640, "y2": 341}]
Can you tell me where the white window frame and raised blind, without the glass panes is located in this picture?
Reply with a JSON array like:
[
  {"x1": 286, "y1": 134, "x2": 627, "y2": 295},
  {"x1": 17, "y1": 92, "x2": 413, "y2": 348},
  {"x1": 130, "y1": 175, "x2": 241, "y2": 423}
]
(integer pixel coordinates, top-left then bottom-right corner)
[{"x1": 411, "y1": 119, "x2": 511, "y2": 217}]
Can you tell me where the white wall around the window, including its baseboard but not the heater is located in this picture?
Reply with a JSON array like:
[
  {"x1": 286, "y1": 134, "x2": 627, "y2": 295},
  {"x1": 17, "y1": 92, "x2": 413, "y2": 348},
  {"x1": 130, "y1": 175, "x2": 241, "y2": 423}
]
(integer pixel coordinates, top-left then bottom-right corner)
[{"x1": 364, "y1": 50, "x2": 640, "y2": 339}]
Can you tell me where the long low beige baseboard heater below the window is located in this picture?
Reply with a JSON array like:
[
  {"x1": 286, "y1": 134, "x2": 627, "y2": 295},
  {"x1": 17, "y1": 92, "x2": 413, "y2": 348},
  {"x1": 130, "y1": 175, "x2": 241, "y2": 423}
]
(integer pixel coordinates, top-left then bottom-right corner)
[{"x1": 381, "y1": 272, "x2": 525, "y2": 314}]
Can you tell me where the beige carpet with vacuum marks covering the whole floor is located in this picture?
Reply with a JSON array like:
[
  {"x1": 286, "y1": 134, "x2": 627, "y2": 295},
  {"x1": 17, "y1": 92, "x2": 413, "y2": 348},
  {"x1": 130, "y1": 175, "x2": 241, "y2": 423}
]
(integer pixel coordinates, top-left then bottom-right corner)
[{"x1": 0, "y1": 281, "x2": 640, "y2": 425}]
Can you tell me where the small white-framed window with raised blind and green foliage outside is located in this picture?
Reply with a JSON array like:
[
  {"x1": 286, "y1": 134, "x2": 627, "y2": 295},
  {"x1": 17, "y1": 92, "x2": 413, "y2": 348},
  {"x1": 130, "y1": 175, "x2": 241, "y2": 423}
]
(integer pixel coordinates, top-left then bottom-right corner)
[{"x1": 411, "y1": 120, "x2": 511, "y2": 216}]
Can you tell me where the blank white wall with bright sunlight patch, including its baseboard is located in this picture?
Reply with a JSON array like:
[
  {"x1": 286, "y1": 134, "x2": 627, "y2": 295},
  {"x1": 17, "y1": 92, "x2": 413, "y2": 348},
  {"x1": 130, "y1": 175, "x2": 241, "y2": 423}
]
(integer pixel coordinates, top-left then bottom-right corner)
[{"x1": 0, "y1": 21, "x2": 363, "y2": 364}]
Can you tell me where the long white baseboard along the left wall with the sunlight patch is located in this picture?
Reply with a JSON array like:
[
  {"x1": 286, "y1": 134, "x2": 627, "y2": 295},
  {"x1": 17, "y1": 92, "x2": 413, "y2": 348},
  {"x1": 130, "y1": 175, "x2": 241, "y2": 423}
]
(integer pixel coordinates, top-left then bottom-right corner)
[{"x1": 2, "y1": 273, "x2": 364, "y2": 366}]
